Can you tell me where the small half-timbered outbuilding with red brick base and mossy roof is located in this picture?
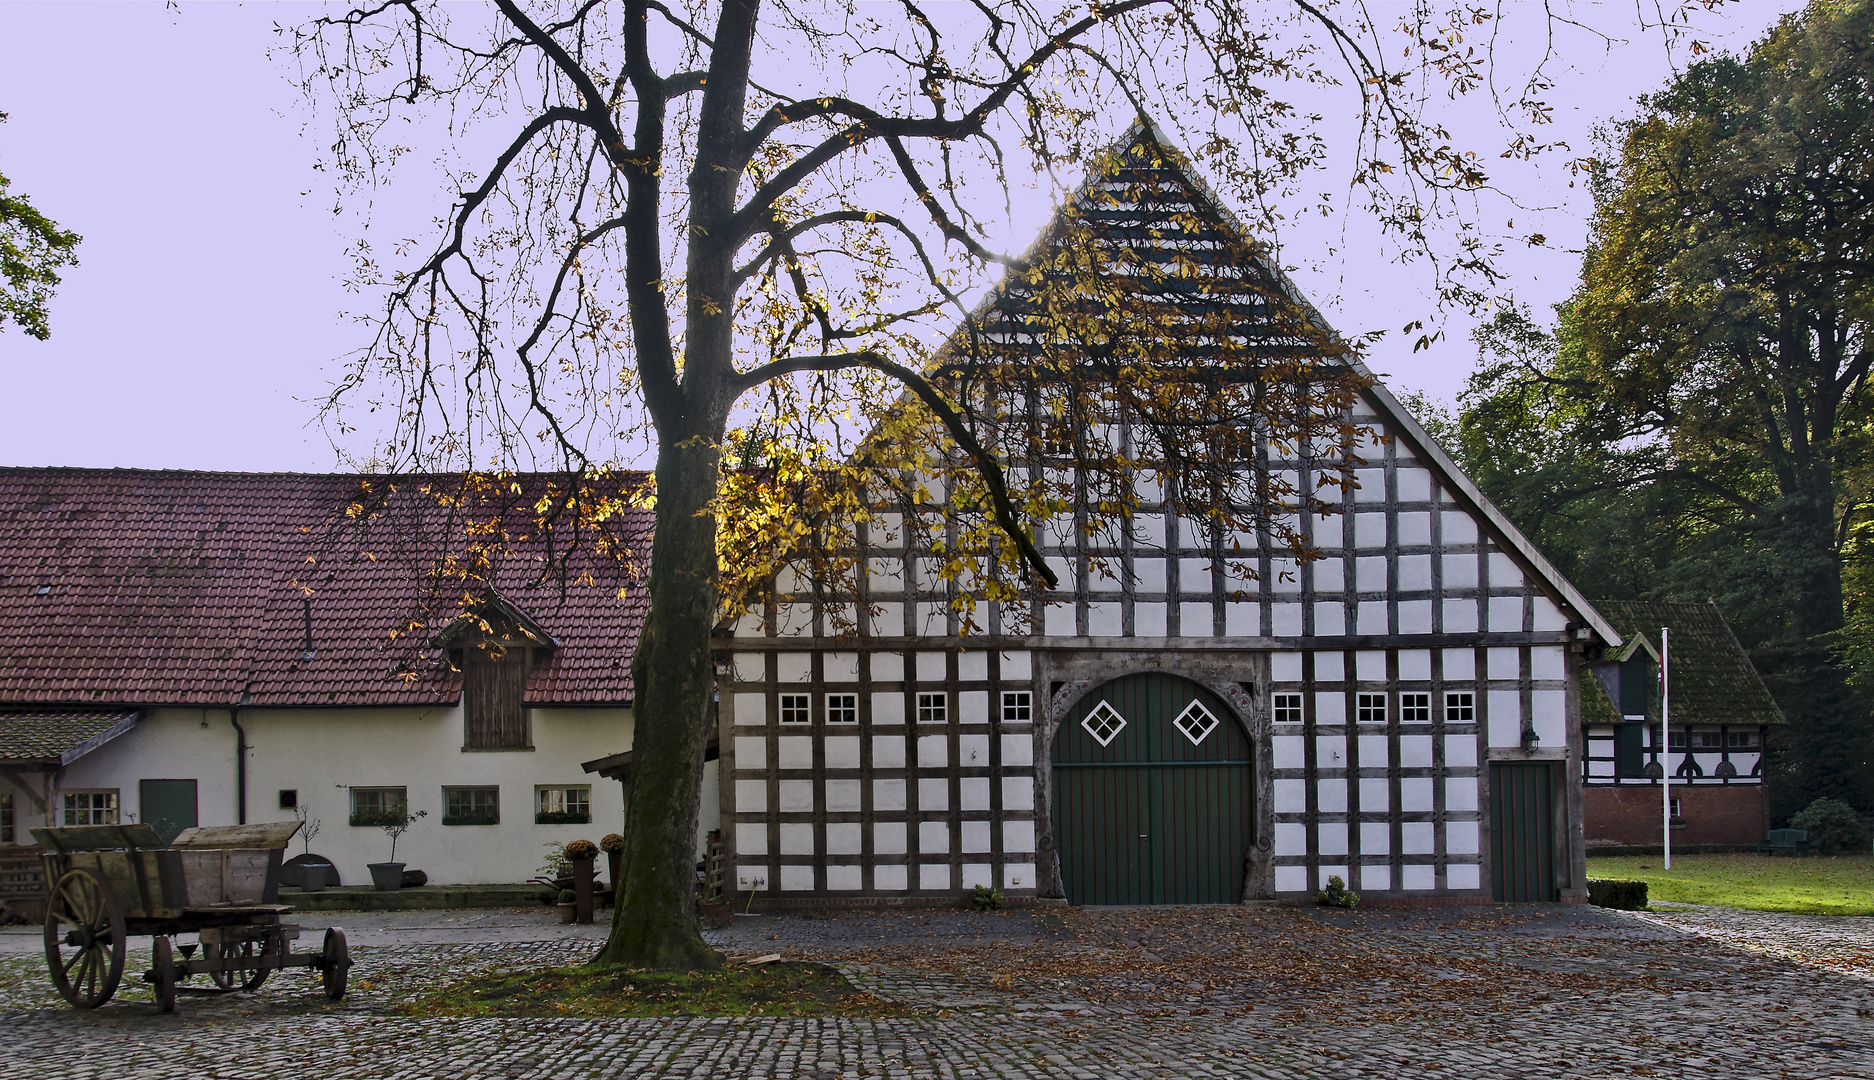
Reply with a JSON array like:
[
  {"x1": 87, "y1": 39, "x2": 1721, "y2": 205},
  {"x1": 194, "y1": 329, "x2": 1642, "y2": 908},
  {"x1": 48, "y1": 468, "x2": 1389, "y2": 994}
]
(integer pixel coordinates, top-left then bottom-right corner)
[{"x1": 1582, "y1": 602, "x2": 1786, "y2": 848}]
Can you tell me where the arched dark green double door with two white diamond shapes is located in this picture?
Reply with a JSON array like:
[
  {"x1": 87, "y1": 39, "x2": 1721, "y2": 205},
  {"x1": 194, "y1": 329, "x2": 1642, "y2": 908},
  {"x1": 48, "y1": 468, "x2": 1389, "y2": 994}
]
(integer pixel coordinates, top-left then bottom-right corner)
[{"x1": 1053, "y1": 675, "x2": 1256, "y2": 904}]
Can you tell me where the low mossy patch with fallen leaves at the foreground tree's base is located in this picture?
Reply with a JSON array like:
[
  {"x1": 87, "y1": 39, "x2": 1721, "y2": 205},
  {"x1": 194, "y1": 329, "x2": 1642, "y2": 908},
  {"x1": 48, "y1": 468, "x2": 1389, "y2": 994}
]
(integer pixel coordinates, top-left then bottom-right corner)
[{"x1": 397, "y1": 962, "x2": 911, "y2": 1016}]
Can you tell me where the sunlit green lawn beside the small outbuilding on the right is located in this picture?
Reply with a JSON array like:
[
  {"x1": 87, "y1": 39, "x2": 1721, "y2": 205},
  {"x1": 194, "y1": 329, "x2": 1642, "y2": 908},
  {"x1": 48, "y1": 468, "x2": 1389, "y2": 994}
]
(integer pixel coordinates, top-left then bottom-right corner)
[{"x1": 1587, "y1": 855, "x2": 1874, "y2": 915}]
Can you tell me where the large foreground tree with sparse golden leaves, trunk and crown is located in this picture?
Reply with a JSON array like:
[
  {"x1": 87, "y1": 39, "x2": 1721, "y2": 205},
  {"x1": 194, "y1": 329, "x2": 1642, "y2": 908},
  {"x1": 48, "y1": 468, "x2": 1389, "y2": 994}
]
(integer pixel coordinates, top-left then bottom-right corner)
[{"x1": 294, "y1": 0, "x2": 1716, "y2": 968}]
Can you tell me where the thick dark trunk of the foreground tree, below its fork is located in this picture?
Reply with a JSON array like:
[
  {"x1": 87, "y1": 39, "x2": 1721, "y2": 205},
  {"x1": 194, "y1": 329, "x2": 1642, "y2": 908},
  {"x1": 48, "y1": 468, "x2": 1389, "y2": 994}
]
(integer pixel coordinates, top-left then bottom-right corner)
[{"x1": 592, "y1": 437, "x2": 721, "y2": 971}]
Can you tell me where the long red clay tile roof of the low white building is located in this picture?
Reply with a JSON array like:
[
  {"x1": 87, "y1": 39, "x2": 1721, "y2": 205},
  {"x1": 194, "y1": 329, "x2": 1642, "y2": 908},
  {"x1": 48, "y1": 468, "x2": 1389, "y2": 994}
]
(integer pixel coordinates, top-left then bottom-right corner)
[{"x1": 0, "y1": 469, "x2": 650, "y2": 707}]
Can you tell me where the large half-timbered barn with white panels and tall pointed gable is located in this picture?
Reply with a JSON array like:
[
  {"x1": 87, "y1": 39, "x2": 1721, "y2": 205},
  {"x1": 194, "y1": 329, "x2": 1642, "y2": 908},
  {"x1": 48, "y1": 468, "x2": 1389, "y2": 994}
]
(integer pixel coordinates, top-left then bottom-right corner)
[{"x1": 720, "y1": 128, "x2": 1623, "y2": 906}]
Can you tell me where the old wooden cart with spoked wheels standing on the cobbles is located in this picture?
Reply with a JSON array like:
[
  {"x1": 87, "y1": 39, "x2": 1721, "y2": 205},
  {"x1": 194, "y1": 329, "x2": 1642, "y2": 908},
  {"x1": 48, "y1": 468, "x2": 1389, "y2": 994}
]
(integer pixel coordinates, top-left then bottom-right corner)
[{"x1": 32, "y1": 821, "x2": 350, "y2": 1013}]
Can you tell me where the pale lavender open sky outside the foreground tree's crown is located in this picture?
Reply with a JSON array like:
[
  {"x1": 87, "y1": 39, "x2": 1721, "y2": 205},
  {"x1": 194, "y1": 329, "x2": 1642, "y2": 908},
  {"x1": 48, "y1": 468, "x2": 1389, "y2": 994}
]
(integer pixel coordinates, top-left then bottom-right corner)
[{"x1": 0, "y1": 0, "x2": 1795, "y2": 471}]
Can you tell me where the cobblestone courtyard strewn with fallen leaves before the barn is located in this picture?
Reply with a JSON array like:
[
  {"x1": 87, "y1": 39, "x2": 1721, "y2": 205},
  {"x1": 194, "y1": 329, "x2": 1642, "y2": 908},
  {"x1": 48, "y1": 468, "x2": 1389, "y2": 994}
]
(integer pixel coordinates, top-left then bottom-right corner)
[{"x1": 0, "y1": 908, "x2": 1874, "y2": 1080}]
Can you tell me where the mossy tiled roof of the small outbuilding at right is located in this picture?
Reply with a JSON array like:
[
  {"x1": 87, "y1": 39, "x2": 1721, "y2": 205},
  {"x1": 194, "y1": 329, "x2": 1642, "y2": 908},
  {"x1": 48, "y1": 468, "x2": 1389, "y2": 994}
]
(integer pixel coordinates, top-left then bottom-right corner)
[{"x1": 1582, "y1": 600, "x2": 1786, "y2": 728}]
